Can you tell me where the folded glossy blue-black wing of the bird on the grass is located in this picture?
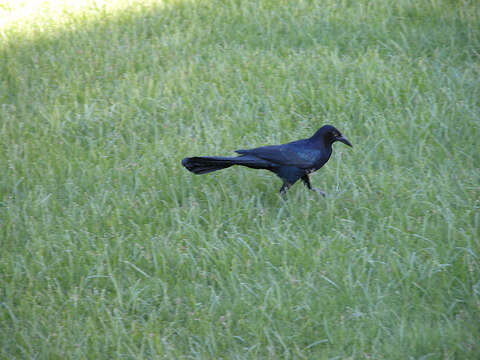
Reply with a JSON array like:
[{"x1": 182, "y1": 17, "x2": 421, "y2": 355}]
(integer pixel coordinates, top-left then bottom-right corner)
[{"x1": 236, "y1": 141, "x2": 321, "y2": 169}]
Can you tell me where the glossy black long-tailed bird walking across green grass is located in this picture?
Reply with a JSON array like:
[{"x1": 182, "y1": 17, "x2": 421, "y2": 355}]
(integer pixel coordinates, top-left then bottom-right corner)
[{"x1": 182, "y1": 125, "x2": 352, "y2": 195}]
